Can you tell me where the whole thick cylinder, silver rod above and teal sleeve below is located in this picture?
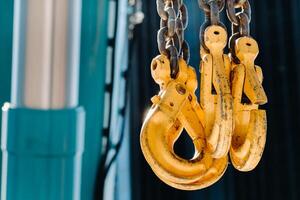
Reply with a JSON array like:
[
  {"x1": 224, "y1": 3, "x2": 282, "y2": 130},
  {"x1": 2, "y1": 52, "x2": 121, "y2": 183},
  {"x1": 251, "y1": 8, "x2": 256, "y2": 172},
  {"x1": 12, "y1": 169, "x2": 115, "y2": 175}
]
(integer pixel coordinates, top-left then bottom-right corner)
[{"x1": 1, "y1": 0, "x2": 85, "y2": 200}]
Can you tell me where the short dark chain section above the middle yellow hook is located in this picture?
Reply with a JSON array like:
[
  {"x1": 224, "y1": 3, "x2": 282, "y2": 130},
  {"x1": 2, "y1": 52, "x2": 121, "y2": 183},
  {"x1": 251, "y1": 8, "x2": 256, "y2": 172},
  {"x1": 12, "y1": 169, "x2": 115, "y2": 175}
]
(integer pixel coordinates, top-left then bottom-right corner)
[{"x1": 198, "y1": 0, "x2": 226, "y2": 51}]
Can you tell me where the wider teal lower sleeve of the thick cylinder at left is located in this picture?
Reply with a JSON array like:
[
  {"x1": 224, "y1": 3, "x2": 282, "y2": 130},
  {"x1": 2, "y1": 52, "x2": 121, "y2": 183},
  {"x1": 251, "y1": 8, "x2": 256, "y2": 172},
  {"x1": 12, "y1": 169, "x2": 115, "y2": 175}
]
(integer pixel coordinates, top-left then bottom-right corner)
[{"x1": 1, "y1": 104, "x2": 85, "y2": 200}]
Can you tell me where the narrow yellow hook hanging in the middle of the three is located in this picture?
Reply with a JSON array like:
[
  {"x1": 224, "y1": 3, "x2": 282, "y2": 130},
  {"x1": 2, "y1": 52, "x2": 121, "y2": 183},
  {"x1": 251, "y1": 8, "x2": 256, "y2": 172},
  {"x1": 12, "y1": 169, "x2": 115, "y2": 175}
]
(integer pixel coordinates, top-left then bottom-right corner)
[{"x1": 200, "y1": 25, "x2": 233, "y2": 158}]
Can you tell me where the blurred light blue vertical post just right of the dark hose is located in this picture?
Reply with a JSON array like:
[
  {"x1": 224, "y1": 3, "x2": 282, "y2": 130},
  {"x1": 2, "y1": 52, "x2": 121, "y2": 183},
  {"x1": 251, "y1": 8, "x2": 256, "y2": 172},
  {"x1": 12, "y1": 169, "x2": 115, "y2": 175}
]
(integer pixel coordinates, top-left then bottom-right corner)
[{"x1": 104, "y1": 0, "x2": 131, "y2": 200}]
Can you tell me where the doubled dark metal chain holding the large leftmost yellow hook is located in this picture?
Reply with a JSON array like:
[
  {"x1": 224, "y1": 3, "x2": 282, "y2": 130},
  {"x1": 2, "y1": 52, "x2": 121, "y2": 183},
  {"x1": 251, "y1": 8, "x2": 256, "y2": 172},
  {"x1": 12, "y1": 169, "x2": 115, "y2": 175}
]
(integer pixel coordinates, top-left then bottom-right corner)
[{"x1": 156, "y1": 0, "x2": 190, "y2": 78}]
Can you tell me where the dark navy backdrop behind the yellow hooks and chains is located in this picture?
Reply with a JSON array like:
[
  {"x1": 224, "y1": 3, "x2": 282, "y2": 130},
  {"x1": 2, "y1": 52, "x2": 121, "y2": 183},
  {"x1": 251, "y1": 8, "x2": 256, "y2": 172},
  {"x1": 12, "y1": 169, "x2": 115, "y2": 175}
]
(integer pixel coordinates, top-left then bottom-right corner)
[{"x1": 130, "y1": 0, "x2": 300, "y2": 200}]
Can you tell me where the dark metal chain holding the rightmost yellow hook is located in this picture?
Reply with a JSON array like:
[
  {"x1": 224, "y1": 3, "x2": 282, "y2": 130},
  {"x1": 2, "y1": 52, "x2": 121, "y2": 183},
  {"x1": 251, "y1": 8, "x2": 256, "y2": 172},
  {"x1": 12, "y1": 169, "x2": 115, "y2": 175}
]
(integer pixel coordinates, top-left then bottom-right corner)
[{"x1": 226, "y1": 0, "x2": 251, "y2": 63}]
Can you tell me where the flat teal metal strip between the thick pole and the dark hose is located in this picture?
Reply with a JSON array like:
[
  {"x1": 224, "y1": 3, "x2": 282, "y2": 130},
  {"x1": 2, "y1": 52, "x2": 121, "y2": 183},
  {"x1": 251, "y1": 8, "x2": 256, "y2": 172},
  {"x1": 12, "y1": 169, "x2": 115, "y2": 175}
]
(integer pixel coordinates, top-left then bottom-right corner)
[{"x1": 79, "y1": 0, "x2": 108, "y2": 200}]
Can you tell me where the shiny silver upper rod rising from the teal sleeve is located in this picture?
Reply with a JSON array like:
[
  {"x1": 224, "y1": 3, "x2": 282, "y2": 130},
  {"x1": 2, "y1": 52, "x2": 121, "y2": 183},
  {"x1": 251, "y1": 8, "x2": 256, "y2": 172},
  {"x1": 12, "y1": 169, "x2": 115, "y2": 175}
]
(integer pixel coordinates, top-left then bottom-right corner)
[{"x1": 11, "y1": 0, "x2": 81, "y2": 109}]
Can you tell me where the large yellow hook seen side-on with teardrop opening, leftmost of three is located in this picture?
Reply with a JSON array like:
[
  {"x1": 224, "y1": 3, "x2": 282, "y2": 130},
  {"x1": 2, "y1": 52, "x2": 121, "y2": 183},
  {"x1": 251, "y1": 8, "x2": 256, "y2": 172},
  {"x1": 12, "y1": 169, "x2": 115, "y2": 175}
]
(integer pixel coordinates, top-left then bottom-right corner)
[{"x1": 140, "y1": 55, "x2": 227, "y2": 190}]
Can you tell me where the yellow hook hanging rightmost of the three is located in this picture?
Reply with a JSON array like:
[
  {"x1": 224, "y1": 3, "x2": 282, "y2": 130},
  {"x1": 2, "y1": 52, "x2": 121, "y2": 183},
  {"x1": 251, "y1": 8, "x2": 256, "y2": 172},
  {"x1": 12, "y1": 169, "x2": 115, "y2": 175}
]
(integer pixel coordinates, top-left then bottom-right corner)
[{"x1": 230, "y1": 36, "x2": 267, "y2": 171}]
